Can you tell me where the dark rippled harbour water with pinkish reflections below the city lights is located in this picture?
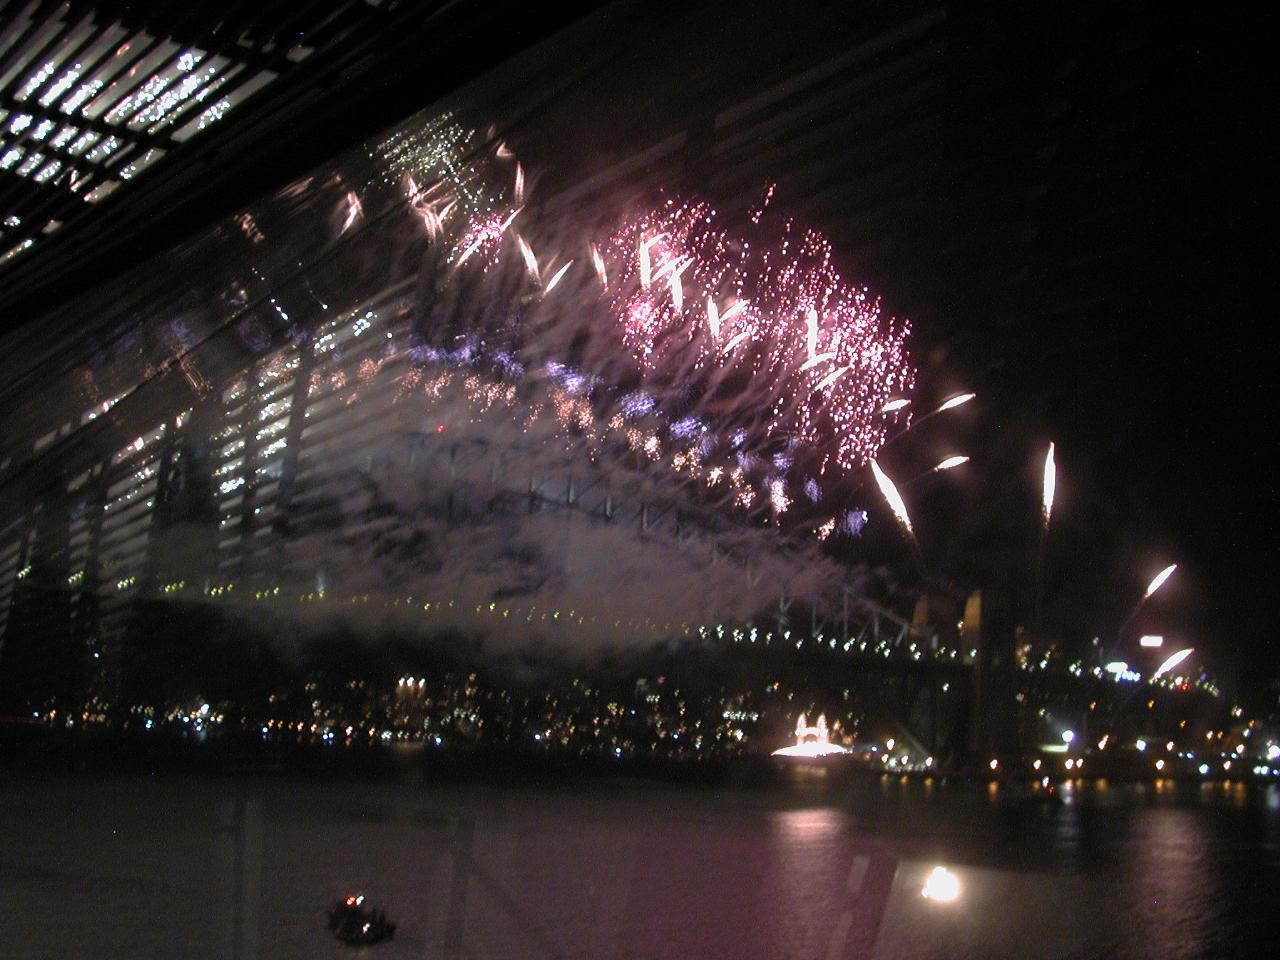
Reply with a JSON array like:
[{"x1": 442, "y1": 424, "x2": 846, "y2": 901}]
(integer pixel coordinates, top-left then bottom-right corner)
[{"x1": 0, "y1": 774, "x2": 1280, "y2": 960}]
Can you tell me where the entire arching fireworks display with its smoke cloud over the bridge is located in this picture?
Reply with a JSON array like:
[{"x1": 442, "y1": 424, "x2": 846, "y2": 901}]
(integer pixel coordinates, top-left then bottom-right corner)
[{"x1": 0, "y1": 108, "x2": 914, "y2": 660}]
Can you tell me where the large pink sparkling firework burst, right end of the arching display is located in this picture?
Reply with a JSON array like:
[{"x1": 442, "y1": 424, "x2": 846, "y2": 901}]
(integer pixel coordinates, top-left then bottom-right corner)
[{"x1": 603, "y1": 200, "x2": 915, "y2": 468}]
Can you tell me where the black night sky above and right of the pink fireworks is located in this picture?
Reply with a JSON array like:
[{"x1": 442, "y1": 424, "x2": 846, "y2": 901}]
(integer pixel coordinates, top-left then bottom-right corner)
[{"x1": 481, "y1": 4, "x2": 1280, "y2": 678}]
